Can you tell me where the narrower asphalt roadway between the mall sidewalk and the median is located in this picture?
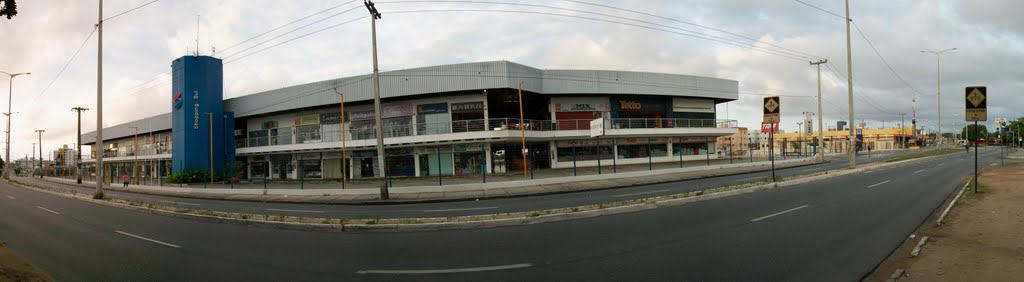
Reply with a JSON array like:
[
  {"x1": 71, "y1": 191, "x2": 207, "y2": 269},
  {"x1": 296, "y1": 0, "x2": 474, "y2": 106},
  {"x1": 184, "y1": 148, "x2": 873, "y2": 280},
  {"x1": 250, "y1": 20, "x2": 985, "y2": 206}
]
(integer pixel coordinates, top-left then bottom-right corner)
[{"x1": 16, "y1": 151, "x2": 921, "y2": 218}]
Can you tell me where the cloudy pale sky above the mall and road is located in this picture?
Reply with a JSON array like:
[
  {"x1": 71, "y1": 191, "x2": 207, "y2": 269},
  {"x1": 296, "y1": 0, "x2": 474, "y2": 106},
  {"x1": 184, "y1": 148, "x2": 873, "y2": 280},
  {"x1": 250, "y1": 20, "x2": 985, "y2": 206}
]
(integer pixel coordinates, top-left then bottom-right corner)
[{"x1": 0, "y1": 0, "x2": 1024, "y2": 158}]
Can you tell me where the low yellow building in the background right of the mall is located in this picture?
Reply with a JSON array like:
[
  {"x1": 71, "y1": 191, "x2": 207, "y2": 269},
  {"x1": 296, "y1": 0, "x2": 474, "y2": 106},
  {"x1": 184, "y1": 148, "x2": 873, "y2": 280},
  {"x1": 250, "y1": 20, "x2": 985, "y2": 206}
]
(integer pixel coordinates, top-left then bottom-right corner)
[{"x1": 774, "y1": 127, "x2": 913, "y2": 153}]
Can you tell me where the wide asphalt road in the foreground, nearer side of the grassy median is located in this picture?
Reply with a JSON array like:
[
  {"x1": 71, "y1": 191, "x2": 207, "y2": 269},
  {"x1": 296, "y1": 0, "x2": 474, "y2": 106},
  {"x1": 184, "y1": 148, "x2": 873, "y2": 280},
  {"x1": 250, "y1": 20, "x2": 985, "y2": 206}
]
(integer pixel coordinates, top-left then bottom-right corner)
[{"x1": 0, "y1": 146, "x2": 998, "y2": 281}]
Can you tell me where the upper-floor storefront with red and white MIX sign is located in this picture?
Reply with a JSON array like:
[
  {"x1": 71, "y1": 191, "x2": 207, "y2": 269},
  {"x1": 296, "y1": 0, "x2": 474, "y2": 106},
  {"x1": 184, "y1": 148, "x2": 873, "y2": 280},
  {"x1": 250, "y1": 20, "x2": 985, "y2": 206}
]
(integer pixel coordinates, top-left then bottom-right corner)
[{"x1": 551, "y1": 97, "x2": 611, "y2": 130}]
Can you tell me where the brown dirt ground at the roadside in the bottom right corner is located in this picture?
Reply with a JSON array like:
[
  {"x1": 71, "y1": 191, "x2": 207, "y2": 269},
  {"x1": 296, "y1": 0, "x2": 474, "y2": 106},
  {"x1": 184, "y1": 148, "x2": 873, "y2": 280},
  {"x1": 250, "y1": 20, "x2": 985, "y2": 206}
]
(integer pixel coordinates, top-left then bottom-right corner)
[{"x1": 864, "y1": 164, "x2": 1024, "y2": 281}]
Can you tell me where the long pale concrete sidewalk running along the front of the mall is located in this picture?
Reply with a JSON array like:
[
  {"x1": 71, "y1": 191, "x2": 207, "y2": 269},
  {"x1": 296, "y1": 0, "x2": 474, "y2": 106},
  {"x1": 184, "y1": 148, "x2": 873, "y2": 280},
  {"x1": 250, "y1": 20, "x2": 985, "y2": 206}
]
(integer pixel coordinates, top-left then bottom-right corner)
[{"x1": 22, "y1": 157, "x2": 818, "y2": 204}]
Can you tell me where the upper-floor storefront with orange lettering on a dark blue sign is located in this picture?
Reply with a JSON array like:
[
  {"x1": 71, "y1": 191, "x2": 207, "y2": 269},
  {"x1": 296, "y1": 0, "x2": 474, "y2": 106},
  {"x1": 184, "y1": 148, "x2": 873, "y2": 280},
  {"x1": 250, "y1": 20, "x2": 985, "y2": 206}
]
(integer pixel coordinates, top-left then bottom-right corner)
[{"x1": 611, "y1": 96, "x2": 671, "y2": 128}]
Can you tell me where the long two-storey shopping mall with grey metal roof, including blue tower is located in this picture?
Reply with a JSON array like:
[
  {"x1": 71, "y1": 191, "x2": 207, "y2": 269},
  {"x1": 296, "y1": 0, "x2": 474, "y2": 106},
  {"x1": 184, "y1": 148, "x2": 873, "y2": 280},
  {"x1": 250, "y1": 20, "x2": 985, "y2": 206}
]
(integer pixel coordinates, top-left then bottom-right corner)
[{"x1": 82, "y1": 55, "x2": 738, "y2": 183}]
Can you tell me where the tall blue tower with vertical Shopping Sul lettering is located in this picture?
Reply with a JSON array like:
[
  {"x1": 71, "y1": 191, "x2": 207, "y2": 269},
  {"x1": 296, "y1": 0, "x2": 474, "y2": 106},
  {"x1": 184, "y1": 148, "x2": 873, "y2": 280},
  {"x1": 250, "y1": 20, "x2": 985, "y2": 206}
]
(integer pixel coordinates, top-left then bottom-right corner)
[{"x1": 171, "y1": 55, "x2": 234, "y2": 174}]
